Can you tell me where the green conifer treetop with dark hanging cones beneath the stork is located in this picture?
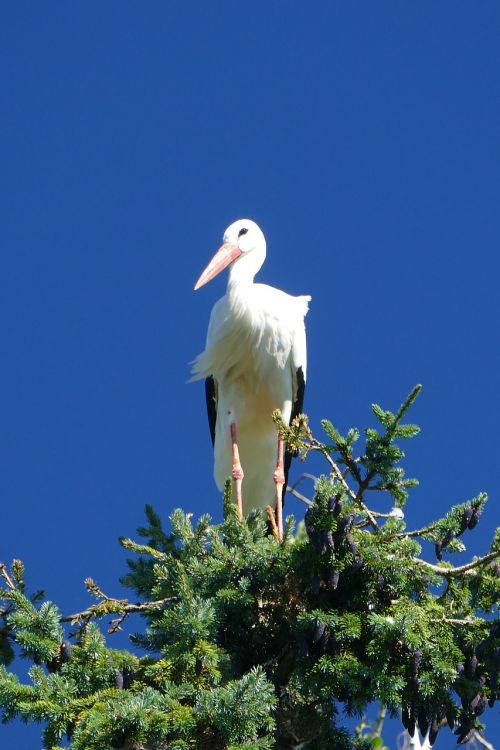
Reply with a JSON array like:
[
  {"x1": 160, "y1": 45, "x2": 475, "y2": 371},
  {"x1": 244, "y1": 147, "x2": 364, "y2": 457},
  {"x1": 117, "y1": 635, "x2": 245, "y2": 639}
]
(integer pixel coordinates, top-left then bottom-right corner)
[{"x1": 0, "y1": 386, "x2": 500, "y2": 750}]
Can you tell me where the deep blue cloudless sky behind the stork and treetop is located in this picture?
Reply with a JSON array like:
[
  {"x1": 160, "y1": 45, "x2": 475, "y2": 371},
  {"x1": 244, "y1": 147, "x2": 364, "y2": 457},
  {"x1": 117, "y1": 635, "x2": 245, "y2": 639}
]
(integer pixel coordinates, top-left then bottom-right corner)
[{"x1": 0, "y1": 0, "x2": 500, "y2": 750}]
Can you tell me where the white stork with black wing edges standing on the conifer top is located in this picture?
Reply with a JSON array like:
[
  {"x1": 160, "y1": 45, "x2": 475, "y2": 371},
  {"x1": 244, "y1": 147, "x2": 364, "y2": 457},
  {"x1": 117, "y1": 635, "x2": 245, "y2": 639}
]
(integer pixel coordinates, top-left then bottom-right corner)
[{"x1": 193, "y1": 219, "x2": 311, "y2": 539}]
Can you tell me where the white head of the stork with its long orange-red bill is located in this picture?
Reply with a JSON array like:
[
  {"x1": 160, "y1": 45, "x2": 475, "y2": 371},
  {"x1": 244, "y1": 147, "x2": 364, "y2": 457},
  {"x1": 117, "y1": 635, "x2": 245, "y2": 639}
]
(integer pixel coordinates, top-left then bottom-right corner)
[{"x1": 194, "y1": 219, "x2": 266, "y2": 290}]
